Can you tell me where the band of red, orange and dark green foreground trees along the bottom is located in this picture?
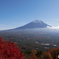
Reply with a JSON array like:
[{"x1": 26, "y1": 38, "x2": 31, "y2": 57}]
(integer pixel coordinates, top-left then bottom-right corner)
[{"x1": 0, "y1": 38, "x2": 59, "y2": 59}]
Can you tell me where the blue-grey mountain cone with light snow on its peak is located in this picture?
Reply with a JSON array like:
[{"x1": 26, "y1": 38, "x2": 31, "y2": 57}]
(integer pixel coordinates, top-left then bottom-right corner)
[{"x1": 15, "y1": 20, "x2": 49, "y2": 30}]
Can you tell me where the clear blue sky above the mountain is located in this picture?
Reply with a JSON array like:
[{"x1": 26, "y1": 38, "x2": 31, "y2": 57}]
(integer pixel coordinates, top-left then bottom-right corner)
[{"x1": 0, "y1": 0, "x2": 59, "y2": 30}]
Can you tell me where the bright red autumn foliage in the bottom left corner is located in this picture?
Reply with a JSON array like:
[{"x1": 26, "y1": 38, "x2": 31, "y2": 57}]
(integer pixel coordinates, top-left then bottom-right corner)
[{"x1": 0, "y1": 38, "x2": 24, "y2": 59}]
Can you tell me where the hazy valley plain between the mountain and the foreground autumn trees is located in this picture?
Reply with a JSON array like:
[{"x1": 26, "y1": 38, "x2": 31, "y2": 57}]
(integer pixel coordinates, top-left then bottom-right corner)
[{"x1": 0, "y1": 31, "x2": 59, "y2": 51}]
